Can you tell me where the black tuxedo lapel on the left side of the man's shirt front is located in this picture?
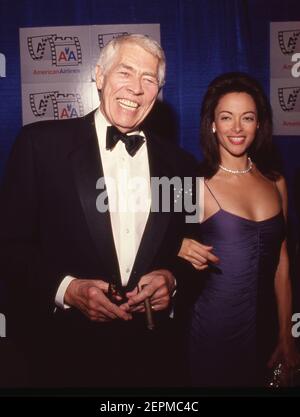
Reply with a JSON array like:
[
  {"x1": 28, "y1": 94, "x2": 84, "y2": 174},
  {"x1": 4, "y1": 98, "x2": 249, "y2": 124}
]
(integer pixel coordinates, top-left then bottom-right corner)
[{"x1": 70, "y1": 112, "x2": 120, "y2": 283}]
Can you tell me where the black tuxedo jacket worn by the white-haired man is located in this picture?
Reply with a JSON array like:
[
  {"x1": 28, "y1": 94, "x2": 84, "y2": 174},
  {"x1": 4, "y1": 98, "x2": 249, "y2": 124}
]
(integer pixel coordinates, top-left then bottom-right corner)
[{"x1": 0, "y1": 112, "x2": 195, "y2": 386}]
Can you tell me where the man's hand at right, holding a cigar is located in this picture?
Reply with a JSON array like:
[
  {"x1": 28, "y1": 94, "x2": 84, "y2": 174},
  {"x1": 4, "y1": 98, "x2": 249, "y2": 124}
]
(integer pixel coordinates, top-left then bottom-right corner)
[{"x1": 120, "y1": 269, "x2": 175, "y2": 312}]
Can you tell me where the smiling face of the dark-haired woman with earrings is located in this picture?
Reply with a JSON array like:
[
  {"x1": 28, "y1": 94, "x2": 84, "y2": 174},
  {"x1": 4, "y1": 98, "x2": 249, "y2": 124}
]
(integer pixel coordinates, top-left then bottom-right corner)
[{"x1": 212, "y1": 92, "x2": 258, "y2": 159}]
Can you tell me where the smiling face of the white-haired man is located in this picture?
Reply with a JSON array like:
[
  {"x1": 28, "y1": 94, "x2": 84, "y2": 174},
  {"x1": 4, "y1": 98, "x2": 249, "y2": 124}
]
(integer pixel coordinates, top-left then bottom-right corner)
[{"x1": 96, "y1": 42, "x2": 159, "y2": 133}]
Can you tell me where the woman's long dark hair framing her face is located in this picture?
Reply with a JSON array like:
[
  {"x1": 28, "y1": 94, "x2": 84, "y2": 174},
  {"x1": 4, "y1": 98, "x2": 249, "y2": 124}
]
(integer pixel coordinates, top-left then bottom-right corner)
[{"x1": 200, "y1": 72, "x2": 279, "y2": 180}]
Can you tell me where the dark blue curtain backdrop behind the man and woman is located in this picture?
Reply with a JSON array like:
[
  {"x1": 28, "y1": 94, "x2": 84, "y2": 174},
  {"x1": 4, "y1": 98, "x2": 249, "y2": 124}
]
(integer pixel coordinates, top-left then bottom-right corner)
[{"x1": 0, "y1": 0, "x2": 300, "y2": 302}]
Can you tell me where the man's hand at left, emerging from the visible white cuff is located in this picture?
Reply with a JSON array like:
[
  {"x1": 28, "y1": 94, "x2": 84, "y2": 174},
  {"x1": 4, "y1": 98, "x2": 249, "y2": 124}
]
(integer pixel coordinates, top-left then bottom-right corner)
[{"x1": 64, "y1": 279, "x2": 132, "y2": 322}]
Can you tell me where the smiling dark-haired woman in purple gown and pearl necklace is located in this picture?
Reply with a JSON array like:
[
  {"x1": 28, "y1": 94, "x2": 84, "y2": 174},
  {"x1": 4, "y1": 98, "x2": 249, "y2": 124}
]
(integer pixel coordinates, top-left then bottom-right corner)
[{"x1": 179, "y1": 73, "x2": 299, "y2": 386}]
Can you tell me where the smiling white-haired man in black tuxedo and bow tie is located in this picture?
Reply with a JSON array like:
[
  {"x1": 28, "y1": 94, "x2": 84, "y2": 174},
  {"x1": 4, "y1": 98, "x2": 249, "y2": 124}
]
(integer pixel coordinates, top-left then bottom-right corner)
[{"x1": 0, "y1": 35, "x2": 198, "y2": 387}]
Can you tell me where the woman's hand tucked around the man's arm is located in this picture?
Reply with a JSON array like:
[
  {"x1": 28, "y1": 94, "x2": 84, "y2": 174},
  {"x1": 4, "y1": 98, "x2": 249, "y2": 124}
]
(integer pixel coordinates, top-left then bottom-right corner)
[{"x1": 178, "y1": 238, "x2": 219, "y2": 271}]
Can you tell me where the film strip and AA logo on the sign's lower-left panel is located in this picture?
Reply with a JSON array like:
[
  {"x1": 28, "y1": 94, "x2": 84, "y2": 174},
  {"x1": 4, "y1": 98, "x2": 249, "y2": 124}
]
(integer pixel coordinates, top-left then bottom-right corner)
[{"x1": 29, "y1": 91, "x2": 84, "y2": 120}]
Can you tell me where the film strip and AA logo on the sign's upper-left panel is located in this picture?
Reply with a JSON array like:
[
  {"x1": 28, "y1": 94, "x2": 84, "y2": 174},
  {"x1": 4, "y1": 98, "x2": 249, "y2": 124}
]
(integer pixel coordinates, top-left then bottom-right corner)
[{"x1": 27, "y1": 34, "x2": 82, "y2": 67}]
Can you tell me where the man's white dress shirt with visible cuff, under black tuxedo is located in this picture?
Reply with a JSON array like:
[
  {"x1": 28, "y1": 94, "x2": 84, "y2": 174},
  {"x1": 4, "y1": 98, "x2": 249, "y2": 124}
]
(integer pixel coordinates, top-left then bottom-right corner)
[{"x1": 55, "y1": 109, "x2": 151, "y2": 308}]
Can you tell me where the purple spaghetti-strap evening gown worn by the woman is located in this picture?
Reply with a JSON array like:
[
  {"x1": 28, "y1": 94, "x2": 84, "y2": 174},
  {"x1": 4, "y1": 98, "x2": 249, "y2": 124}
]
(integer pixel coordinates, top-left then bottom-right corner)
[{"x1": 189, "y1": 185, "x2": 285, "y2": 387}]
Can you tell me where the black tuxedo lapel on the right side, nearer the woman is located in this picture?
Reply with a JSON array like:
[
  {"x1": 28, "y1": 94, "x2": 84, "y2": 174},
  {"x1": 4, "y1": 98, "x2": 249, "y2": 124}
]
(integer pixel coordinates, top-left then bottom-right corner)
[{"x1": 128, "y1": 134, "x2": 171, "y2": 288}]
